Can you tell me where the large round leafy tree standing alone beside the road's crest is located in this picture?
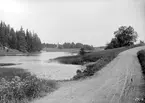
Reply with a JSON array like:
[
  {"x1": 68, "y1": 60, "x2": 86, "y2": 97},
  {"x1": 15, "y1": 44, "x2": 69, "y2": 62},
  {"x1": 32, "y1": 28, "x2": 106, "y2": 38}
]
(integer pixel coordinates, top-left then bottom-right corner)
[{"x1": 105, "y1": 26, "x2": 138, "y2": 49}]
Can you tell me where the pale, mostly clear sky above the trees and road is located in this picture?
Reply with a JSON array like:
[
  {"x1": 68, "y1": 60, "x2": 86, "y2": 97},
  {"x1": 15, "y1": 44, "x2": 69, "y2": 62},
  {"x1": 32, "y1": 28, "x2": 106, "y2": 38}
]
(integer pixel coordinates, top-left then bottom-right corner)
[{"x1": 0, "y1": 0, "x2": 145, "y2": 46}]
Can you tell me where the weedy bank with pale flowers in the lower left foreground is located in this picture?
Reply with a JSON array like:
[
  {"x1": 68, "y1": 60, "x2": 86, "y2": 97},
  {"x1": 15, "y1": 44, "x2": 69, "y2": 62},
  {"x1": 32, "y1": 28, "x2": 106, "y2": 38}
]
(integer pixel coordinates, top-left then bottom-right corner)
[{"x1": 0, "y1": 68, "x2": 57, "y2": 103}]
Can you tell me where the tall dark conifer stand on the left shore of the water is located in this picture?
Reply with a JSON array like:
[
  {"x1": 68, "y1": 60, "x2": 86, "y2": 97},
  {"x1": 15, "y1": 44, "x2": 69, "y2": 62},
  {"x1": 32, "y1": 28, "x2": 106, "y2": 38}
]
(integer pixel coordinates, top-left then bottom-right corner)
[{"x1": 0, "y1": 21, "x2": 42, "y2": 52}]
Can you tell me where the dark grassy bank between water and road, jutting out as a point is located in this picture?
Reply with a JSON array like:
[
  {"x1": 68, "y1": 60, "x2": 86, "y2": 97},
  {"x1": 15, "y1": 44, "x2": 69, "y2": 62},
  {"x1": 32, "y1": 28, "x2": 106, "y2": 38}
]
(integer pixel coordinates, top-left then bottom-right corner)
[{"x1": 55, "y1": 44, "x2": 142, "y2": 80}]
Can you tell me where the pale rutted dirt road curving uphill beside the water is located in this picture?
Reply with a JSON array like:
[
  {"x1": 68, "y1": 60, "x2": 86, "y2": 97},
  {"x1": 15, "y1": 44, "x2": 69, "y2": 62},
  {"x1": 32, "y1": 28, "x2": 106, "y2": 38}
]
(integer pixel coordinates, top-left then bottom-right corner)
[{"x1": 33, "y1": 47, "x2": 145, "y2": 103}]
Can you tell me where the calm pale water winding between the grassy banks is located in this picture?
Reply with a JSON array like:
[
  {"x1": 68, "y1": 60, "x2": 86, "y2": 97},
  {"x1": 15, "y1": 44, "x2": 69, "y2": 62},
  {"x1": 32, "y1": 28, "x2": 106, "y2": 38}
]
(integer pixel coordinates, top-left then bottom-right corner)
[{"x1": 0, "y1": 52, "x2": 81, "y2": 80}]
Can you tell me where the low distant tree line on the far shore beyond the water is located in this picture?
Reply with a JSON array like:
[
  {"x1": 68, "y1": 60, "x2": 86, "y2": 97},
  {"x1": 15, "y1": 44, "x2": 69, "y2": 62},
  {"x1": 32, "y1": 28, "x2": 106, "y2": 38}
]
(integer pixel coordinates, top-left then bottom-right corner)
[{"x1": 42, "y1": 42, "x2": 94, "y2": 50}]
